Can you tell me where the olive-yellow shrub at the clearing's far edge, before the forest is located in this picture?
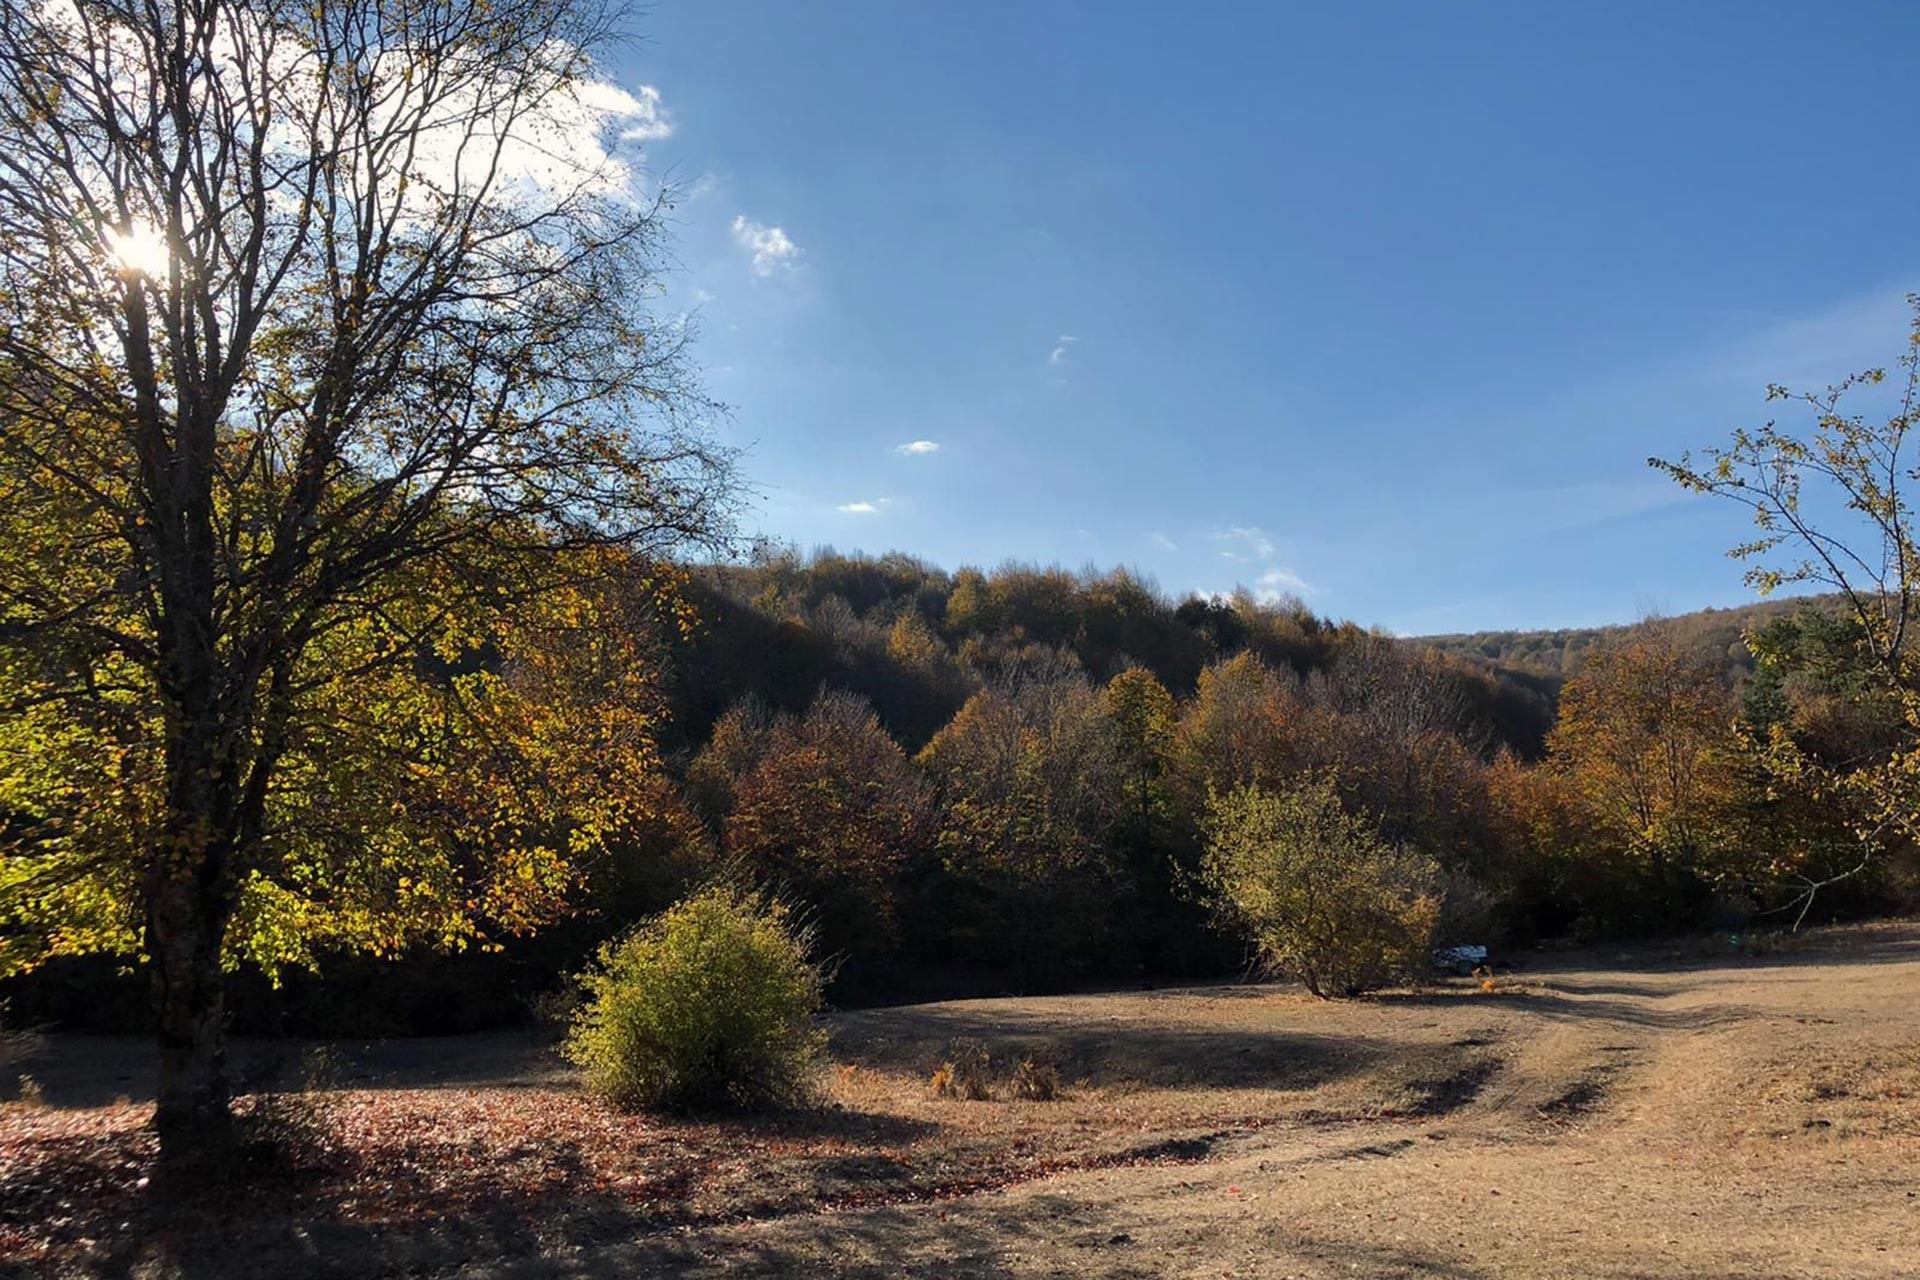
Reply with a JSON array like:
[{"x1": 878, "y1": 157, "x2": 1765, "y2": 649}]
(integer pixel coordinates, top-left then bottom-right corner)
[{"x1": 1202, "y1": 773, "x2": 1440, "y2": 998}]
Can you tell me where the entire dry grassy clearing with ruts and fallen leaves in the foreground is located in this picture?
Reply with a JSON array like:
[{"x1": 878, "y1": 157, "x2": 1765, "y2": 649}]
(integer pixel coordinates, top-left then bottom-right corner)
[{"x1": 0, "y1": 925, "x2": 1920, "y2": 1278}]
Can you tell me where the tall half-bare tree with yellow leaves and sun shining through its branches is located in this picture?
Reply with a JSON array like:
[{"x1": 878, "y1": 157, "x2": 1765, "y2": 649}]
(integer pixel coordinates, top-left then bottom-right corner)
[{"x1": 0, "y1": 0, "x2": 726, "y2": 1157}]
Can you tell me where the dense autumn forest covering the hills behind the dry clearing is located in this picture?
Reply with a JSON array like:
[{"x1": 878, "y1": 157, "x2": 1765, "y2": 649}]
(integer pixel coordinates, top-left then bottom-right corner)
[{"x1": 13, "y1": 549, "x2": 1912, "y2": 1034}]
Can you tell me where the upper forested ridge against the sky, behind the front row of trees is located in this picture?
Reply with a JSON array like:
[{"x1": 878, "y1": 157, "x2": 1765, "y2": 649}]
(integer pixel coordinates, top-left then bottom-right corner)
[{"x1": 674, "y1": 551, "x2": 1557, "y2": 756}]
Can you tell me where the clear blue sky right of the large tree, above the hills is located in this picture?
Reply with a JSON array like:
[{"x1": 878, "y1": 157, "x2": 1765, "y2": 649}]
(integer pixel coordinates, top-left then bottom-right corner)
[{"x1": 607, "y1": 0, "x2": 1920, "y2": 633}]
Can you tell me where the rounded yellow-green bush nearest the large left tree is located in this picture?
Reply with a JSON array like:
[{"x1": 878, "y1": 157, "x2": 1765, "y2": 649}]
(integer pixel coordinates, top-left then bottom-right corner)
[{"x1": 564, "y1": 889, "x2": 826, "y2": 1109}]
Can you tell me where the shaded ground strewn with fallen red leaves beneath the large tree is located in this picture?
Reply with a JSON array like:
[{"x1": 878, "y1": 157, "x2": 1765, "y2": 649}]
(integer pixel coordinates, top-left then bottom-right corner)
[{"x1": 0, "y1": 1102, "x2": 939, "y2": 1280}]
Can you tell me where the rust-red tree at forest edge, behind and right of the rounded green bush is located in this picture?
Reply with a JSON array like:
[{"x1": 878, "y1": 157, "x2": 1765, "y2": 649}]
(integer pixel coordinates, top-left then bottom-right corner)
[{"x1": 726, "y1": 691, "x2": 927, "y2": 956}]
